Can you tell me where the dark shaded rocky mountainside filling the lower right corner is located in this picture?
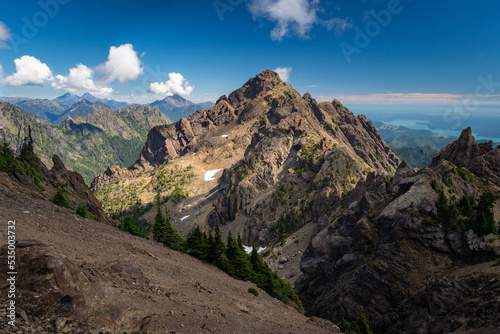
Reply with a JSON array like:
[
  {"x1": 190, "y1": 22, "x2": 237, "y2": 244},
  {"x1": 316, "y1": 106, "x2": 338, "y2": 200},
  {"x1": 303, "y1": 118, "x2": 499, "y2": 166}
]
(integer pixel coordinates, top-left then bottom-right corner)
[{"x1": 299, "y1": 128, "x2": 500, "y2": 333}]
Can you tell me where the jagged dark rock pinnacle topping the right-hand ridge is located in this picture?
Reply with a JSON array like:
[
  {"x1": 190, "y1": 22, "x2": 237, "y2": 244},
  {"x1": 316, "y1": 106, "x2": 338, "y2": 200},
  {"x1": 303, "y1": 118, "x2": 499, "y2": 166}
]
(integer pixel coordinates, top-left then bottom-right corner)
[{"x1": 432, "y1": 127, "x2": 493, "y2": 167}]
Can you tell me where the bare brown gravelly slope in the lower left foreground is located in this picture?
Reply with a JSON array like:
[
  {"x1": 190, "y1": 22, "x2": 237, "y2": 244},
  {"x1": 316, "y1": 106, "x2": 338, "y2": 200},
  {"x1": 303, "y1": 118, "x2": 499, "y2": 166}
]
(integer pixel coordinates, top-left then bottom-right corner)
[{"x1": 0, "y1": 162, "x2": 340, "y2": 334}]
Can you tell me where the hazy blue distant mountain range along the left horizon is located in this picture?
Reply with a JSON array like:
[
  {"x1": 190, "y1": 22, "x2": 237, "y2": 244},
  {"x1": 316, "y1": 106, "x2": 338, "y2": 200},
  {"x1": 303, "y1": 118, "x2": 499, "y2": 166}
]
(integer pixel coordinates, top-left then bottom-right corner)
[{"x1": 0, "y1": 93, "x2": 214, "y2": 125}]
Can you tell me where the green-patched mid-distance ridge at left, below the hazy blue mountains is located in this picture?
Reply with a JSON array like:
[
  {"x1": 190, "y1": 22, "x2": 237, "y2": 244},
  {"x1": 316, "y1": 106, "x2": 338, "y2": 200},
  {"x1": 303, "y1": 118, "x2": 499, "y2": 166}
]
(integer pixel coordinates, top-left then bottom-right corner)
[{"x1": 0, "y1": 102, "x2": 171, "y2": 183}]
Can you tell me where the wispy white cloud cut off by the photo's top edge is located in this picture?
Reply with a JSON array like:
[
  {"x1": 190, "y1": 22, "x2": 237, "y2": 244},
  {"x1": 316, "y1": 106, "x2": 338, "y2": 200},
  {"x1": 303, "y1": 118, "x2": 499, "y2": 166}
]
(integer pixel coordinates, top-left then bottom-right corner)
[{"x1": 248, "y1": 0, "x2": 352, "y2": 40}]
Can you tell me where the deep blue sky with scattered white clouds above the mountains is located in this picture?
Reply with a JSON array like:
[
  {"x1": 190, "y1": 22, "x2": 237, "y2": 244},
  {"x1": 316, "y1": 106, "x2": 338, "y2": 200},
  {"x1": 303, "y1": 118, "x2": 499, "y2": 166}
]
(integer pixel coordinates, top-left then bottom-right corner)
[{"x1": 0, "y1": 0, "x2": 500, "y2": 112}]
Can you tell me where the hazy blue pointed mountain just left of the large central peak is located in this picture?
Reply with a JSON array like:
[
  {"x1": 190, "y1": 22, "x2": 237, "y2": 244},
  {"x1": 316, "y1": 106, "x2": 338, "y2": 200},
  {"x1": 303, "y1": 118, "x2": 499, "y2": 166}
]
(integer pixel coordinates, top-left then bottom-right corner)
[{"x1": 149, "y1": 94, "x2": 214, "y2": 122}]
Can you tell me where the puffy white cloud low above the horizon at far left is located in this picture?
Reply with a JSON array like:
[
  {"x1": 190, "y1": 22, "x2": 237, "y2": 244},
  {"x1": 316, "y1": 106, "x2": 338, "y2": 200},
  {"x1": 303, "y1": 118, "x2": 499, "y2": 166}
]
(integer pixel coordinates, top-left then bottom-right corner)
[{"x1": 2, "y1": 56, "x2": 54, "y2": 86}]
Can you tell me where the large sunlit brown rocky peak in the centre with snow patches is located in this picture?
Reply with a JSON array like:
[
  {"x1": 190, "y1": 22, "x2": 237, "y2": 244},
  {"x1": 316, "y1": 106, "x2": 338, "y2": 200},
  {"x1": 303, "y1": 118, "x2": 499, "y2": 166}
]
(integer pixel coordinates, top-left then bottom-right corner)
[{"x1": 92, "y1": 70, "x2": 399, "y2": 282}]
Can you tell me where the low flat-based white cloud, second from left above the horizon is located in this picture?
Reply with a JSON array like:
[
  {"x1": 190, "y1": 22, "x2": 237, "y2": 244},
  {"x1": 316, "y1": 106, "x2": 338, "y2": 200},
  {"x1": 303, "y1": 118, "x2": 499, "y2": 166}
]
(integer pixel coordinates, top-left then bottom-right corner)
[{"x1": 52, "y1": 64, "x2": 113, "y2": 96}]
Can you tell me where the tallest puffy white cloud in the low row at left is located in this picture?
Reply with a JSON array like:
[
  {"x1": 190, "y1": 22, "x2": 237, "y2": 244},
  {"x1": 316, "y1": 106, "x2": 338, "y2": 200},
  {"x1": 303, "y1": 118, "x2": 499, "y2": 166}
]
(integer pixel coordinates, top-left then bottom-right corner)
[{"x1": 96, "y1": 44, "x2": 144, "y2": 84}]
